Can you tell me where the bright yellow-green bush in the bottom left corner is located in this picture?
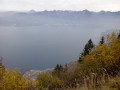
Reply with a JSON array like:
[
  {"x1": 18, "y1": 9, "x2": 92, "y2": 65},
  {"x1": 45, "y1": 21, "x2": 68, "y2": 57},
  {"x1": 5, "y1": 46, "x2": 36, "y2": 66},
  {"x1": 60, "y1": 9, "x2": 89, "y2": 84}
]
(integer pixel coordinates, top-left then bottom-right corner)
[{"x1": 1, "y1": 70, "x2": 28, "y2": 90}]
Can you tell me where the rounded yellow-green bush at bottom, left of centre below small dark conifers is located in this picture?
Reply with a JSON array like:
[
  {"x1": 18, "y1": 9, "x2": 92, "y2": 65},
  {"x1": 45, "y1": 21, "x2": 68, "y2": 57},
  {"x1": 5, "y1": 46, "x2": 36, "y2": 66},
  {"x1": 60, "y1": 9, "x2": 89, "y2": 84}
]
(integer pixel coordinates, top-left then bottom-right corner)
[{"x1": 36, "y1": 73, "x2": 62, "y2": 90}]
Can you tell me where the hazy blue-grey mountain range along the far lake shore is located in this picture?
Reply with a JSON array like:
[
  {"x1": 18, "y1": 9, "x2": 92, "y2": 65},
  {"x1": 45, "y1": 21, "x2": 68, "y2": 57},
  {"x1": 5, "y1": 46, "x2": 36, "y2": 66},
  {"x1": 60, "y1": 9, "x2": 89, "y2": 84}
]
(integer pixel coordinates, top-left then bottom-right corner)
[{"x1": 0, "y1": 10, "x2": 120, "y2": 26}]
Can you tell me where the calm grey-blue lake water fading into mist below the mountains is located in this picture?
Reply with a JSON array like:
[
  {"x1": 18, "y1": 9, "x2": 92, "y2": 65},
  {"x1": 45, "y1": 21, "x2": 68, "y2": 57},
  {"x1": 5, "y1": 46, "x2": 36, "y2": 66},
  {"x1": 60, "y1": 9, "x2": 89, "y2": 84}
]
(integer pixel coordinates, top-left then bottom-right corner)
[{"x1": 0, "y1": 12, "x2": 120, "y2": 72}]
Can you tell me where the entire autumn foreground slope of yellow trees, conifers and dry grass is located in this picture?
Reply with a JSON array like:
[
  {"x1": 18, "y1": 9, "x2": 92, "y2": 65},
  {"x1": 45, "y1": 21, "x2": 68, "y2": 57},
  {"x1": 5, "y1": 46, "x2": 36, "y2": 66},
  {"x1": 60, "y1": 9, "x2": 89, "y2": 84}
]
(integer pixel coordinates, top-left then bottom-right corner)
[{"x1": 0, "y1": 33, "x2": 120, "y2": 90}]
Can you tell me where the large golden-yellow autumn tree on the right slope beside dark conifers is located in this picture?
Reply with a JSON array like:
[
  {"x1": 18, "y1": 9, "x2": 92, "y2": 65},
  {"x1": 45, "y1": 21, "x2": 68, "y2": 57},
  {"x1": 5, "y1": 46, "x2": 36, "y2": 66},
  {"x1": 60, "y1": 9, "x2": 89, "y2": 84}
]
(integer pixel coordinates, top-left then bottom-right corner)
[{"x1": 83, "y1": 33, "x2": 120, "y2": 76}]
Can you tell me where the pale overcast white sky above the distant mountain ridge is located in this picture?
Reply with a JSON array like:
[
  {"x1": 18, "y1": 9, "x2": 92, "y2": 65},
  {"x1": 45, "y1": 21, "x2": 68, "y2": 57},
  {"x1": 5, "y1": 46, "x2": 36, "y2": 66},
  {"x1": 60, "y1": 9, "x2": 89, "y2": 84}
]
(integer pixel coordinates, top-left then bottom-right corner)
[{"x1": 0, "y1": 0, "x2": 120, "y2": 11}]
